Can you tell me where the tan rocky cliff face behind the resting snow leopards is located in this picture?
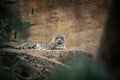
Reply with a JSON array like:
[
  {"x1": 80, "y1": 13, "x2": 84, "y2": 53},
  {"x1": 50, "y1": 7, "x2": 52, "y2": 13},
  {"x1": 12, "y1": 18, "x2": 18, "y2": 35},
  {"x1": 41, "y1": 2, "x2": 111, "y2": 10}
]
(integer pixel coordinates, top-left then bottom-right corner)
[{"x1": 17, "y1": 0, "x2": 109, "y2": 53}]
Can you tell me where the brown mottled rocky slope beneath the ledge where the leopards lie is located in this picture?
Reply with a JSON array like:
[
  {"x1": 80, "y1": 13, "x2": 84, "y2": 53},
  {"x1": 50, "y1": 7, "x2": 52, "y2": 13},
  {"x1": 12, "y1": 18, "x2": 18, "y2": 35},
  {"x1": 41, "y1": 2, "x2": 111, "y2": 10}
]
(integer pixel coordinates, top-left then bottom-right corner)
[{"x1": 0, "y1": 50, "x2": 94, "y2": 80}]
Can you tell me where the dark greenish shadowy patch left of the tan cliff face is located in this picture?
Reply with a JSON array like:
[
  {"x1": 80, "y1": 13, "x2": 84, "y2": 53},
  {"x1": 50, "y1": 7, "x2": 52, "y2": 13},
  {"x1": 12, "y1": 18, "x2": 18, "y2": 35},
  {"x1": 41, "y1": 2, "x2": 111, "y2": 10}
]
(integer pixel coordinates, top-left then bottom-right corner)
[{"x1": 0, "y1": 0, "x2": 33, "y2": 43}]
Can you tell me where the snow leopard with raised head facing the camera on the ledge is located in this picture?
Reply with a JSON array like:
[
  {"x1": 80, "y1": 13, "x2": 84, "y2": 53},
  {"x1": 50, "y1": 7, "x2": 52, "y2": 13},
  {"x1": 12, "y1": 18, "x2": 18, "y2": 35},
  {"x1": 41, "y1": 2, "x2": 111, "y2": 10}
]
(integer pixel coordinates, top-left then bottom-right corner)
[{"x1": 46, "y1": 34, "x2": 66, "y2": 50}]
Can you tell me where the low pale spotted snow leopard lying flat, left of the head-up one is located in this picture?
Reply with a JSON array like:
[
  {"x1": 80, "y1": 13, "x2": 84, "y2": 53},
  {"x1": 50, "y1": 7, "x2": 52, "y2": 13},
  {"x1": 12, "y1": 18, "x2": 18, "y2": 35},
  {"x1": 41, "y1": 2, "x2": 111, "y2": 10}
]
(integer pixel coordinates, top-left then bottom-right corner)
[{"x1": 16, "y1": 42, "x2": 41, "y2": 50}]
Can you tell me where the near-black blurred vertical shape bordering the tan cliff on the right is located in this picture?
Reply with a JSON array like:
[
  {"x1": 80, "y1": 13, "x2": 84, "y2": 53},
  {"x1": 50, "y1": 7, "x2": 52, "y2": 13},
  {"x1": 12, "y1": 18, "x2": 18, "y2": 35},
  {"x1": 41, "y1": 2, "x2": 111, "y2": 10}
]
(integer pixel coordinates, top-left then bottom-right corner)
[{"x1": 99, "y1": 0, "x2": 120, "y2": 80}]
